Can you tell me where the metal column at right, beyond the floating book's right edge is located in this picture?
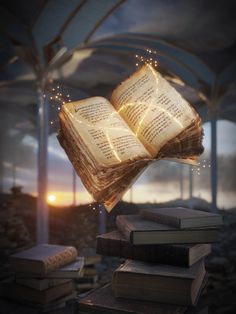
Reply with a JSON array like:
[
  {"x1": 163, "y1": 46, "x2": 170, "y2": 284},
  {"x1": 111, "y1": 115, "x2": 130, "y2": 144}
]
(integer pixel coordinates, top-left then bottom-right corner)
[{"x1": 211, "y1": 115, "x2": 218, "y2": 212}]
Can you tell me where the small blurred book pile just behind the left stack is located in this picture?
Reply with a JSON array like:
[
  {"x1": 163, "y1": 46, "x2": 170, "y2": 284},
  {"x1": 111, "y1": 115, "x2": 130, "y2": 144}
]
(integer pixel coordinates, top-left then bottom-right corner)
[{"x1": 76, "y1": 248, "x2": 101, "y2": 293}]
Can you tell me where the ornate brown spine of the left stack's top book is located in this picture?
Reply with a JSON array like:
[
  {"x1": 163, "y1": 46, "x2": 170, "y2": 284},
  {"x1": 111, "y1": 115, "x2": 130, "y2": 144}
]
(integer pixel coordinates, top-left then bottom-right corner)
[{"x1": 43, "y1": 247, "x2": 77, "y2": 275}]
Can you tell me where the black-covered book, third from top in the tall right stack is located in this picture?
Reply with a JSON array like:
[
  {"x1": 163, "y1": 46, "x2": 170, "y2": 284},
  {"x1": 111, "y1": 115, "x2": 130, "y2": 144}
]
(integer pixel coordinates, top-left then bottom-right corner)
[{"x1": 97, "y1": 230, "x2": 211, "y2": 267}]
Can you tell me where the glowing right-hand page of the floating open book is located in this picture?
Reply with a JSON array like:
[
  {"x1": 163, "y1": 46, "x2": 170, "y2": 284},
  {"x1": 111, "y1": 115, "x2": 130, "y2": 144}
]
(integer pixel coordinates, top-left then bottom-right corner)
[{"x1": 111, "y1": 65, "x2": 196, "y2": 157}]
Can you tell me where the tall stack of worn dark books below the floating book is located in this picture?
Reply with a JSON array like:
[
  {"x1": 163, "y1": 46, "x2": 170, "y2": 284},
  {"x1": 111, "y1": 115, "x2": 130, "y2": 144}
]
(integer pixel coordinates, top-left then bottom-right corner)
[{"x1": 79, "y1": 207, "x2": 223, "y2": 314}]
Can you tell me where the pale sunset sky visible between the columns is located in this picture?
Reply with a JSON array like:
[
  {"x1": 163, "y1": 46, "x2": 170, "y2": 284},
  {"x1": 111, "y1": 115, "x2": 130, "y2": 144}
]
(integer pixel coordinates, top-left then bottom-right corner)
[{"x1": 4, "y1": 121, "x2": 236, "y2": 207}]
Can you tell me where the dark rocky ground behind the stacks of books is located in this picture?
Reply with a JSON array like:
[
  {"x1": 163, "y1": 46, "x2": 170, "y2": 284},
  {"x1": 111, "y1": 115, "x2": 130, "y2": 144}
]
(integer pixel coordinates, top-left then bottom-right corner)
[{"x1": 0, "y1": 195, "x2": 236, "y2": 314}]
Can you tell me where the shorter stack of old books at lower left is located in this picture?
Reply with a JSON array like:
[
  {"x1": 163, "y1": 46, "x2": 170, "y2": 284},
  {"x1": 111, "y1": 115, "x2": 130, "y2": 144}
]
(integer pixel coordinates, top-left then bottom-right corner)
[{"x1": 1, "y1": 244, "x2": 84, "y2": 311}]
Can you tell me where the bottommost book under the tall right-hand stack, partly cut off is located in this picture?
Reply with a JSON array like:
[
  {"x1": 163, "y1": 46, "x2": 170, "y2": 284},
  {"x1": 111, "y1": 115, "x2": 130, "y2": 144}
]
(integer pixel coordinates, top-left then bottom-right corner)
[{"x1": 78, "y1": 284, "x2": 187, "y2": 314}]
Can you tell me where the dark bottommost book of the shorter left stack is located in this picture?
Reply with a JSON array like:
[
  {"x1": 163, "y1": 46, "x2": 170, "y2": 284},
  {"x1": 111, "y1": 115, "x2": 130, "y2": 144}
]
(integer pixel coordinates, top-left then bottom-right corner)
[{"x1": 2, "y1": 281, "x2": 74, "y2": 305}]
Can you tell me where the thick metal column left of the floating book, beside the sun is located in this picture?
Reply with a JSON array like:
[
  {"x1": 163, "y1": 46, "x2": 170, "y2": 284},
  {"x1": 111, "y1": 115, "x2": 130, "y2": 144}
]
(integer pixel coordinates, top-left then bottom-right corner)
[{"x1": 37, "y1": 86, "x2": 49, "y2": 244}]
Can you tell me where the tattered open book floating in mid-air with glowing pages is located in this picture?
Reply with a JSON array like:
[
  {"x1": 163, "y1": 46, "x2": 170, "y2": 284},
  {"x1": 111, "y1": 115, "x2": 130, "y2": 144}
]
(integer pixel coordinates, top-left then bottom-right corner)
[{"x1": 58, "y1": 65, "x2": 203, "y2": 211}]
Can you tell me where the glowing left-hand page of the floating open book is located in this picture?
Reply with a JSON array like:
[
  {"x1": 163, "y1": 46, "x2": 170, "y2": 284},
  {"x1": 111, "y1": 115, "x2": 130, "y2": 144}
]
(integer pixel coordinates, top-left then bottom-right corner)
[{"x1": 63, "y1": 97, "x2": 150, "y2": 166}]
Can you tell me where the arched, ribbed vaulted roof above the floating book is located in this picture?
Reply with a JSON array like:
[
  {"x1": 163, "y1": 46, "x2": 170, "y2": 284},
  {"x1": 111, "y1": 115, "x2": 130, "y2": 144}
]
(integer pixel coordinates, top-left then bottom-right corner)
[{"x1": 0, "y1": 0, "x2": 236, "y2": 135}]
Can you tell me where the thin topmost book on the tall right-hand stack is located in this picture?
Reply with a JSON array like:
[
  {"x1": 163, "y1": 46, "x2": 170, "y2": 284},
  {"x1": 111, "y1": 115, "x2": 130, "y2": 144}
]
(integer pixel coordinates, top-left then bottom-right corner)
[{"x1": 141, "y1": 207, "x2": 223, "y2": 229}]
